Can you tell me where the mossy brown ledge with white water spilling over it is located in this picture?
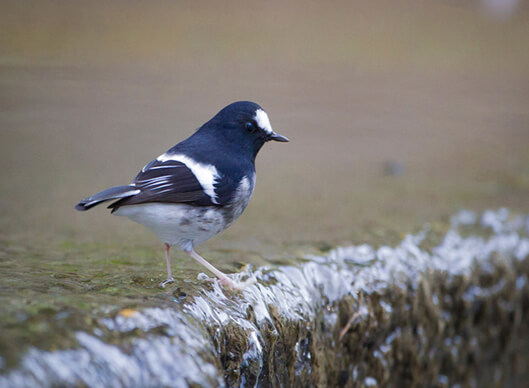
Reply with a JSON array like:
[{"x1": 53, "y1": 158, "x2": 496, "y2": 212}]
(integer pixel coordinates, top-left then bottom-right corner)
[{"x1": 0, "y1": 209, "x2": 529, "y2": 387}]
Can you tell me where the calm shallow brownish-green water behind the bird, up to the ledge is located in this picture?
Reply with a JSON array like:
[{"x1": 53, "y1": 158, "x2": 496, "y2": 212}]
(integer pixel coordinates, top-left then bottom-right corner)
[{"x1": 0, "y1": 64, "x2": 529, "y2": 349}]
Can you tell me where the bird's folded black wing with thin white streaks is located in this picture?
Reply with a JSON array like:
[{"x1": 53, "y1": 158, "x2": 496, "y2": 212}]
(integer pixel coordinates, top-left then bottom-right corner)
[{"x1": 109, "y1": 159, "x2": 217, "y2": 210}]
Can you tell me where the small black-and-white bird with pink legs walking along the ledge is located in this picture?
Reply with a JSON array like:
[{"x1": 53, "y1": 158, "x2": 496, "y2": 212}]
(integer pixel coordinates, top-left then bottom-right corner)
[{"x1": 75, "y1": 101, "x2": 289, "y2": 290}]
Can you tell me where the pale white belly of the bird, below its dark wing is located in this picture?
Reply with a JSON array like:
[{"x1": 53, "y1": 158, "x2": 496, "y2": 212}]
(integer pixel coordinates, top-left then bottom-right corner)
[{"x1": 114, "y1": 203, "x2": 228, "y2": 251}]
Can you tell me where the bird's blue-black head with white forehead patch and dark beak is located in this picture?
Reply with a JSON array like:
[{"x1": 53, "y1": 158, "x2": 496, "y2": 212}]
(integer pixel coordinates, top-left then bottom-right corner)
[{"x1": 204, "y1": 101, "x2": 289, "y2": 158}]
